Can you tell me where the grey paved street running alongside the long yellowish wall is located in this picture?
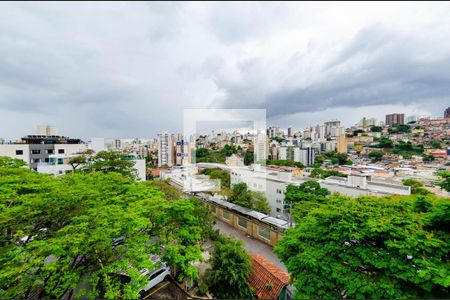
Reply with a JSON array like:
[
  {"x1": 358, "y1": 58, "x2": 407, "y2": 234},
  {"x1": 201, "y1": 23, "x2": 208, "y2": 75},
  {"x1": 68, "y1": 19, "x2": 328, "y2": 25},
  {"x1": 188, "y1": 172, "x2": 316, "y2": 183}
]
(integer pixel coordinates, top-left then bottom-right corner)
[{"x1": 214, "y1": 219, "x2": 287, "y2": 272}]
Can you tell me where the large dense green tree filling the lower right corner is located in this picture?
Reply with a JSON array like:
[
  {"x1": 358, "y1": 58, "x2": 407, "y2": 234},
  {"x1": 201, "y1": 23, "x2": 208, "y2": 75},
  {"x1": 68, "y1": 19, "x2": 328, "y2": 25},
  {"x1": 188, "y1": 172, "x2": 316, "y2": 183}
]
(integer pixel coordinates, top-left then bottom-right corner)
[{"x1": 274, "y1": 195, "x2": 450, "y2": 299}]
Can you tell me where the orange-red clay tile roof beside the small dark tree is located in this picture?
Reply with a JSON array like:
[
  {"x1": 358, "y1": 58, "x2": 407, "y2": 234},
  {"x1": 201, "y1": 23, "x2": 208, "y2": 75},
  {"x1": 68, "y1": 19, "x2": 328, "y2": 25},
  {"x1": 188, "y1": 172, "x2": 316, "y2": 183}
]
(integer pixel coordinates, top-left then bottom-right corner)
[{"x1": 248, "y1": 254, "x2": 290, "y2": 300}]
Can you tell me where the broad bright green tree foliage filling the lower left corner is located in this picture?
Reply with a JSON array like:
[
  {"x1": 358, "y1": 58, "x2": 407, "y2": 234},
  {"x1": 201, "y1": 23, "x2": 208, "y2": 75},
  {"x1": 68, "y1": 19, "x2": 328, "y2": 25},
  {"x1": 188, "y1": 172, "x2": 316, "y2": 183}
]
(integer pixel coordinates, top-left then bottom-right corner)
[{"x1": 0, "y1": 166, "x2": 207, "y2": 299}]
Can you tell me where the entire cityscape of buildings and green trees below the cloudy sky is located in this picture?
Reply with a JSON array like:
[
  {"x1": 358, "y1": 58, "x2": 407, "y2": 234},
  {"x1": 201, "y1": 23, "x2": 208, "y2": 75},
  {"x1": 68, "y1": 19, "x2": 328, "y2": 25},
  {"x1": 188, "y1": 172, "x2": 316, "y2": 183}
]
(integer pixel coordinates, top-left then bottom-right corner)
[{"x1": 0, "y1": 109, "x2": 450, "y2": 299}]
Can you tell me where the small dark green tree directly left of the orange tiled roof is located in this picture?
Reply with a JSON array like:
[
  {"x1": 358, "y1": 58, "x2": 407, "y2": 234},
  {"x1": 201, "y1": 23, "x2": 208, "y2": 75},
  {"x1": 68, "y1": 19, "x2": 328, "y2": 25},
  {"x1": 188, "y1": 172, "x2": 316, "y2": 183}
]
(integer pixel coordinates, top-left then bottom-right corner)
[{"x1": 206, "y1": 236, "x2": 255, "y2": 299}]
